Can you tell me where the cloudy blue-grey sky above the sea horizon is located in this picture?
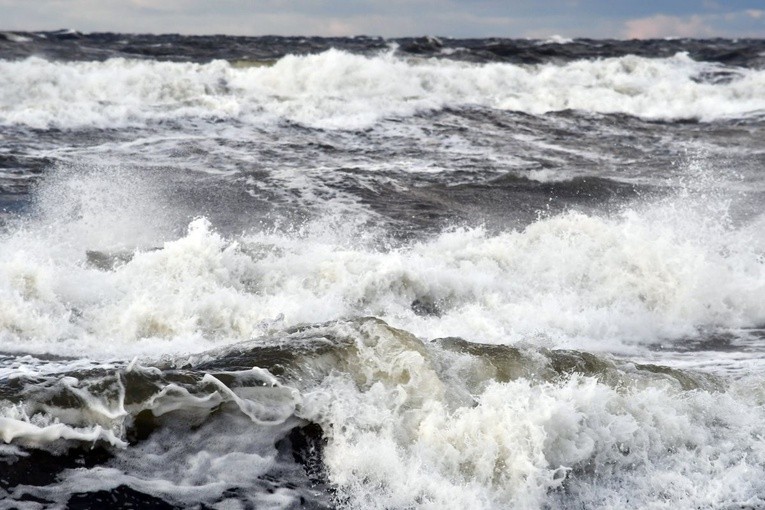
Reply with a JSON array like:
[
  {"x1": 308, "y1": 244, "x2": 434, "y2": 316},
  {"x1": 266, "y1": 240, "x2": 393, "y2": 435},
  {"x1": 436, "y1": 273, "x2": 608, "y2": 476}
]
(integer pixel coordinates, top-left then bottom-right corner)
[{"x1": 0, "y1": 0, "x2": 765, "y2": 39}]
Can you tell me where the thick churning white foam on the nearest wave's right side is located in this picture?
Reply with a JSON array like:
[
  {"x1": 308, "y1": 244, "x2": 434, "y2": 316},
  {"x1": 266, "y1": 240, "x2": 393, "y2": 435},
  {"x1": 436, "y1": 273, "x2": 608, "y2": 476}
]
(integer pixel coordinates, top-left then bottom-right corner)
[{"x1": 296, "y1": 323, "x2": 765, "y2": 509}]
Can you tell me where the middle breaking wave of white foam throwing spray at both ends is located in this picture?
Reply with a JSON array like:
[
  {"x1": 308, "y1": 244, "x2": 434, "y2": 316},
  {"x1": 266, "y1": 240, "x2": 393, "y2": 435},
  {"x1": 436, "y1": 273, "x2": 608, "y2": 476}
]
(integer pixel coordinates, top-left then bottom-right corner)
[{"x1": 0, "y1": 161, "x2": 765, "y2": 359}]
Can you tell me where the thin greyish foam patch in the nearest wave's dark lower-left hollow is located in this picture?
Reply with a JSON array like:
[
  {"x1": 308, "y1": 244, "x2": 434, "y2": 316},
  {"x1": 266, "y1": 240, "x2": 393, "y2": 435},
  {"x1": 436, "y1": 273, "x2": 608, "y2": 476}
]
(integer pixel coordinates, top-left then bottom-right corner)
[{"x1": 27, "y1": 414, "x2": 300, "y2": 509}]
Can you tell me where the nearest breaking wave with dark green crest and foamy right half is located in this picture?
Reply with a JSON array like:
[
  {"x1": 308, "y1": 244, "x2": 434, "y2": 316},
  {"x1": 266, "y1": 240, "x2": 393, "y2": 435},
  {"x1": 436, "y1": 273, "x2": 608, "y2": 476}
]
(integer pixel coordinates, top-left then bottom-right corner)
[{"x1": 0, "y1": 318, "x2": 765, "y2": 509}]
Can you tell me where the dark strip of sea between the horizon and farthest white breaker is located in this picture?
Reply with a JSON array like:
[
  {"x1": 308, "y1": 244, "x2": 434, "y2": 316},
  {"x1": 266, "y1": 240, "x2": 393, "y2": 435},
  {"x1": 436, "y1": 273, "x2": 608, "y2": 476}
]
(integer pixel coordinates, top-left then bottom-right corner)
[{"x1": 0, "y1": 30, "x2": 765, "y2": 68}]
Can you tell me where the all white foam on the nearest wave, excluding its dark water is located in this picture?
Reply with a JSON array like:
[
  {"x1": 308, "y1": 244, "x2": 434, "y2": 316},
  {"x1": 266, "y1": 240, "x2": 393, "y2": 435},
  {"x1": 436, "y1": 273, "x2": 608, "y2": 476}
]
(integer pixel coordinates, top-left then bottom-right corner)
[{"x1": 0, "y1": 319, "x2": 765, "y2": 509}]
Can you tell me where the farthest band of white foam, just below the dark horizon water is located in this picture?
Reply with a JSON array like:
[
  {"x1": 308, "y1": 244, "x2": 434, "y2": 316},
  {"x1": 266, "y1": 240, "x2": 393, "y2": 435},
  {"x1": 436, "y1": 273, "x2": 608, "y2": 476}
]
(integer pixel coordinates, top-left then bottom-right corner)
[{"x1": 0, "y1": 50, "x2": 765, "y2": 129}]
